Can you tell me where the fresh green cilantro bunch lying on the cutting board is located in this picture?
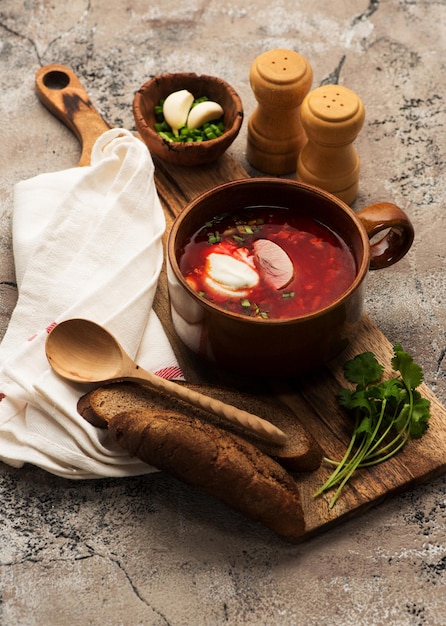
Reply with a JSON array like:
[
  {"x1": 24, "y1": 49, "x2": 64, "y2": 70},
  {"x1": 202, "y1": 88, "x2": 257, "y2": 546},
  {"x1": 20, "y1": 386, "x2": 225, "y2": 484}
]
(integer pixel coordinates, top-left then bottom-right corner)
[{"x1": 314, "y1": 343, "x2": 430, "y2": 508}]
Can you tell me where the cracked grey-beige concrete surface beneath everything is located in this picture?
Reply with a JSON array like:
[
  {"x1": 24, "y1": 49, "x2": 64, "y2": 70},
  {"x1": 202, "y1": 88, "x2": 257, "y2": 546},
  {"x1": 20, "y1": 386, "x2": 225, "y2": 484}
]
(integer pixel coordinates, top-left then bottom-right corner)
[{"x1": 0, "y1": 0, "x2": 446, "y2": 626}]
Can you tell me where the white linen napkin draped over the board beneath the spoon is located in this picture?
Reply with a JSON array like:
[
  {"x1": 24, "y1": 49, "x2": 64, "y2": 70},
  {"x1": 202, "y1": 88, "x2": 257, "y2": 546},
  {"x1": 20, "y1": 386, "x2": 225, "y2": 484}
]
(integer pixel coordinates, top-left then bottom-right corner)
[{"x1": 0, "y1": 129, "x2": 182, "y2": 478}]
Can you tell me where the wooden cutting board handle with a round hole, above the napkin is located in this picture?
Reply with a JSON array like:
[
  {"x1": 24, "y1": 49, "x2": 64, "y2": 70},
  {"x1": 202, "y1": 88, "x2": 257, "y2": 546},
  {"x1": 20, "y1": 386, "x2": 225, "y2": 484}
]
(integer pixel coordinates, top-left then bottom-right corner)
[{"x1": 35, "y1": 64, "x2": 111, "y2": 165}]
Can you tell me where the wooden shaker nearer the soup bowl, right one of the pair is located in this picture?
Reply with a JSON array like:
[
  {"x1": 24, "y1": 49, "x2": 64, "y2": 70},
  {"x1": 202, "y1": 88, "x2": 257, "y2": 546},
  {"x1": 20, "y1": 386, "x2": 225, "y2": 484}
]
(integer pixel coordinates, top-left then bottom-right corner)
[{"x1": 296, "y1": 85, "x2": 365, "y2": 204}]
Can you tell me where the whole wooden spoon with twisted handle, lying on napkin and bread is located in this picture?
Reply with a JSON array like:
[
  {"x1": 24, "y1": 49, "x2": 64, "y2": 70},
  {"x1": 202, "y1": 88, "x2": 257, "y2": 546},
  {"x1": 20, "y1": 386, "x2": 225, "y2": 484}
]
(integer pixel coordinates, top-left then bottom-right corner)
[{"x1": 45, "y1": 319, "x2": 287, "y2": 443}]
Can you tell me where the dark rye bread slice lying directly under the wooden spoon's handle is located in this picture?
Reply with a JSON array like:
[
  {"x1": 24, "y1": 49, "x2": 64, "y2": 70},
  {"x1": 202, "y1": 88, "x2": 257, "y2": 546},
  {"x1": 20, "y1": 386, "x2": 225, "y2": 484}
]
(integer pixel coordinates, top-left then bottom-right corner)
[{"x1": 78, "y1": 382, "x2": 322, "y2": 472}]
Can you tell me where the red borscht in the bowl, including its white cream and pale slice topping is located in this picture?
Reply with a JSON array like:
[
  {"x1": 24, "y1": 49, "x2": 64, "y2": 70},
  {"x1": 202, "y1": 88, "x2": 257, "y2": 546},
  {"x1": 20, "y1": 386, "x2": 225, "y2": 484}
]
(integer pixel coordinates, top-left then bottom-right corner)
[{"x1": 180, "y1": 206, "x2": 356, "y2": 319}]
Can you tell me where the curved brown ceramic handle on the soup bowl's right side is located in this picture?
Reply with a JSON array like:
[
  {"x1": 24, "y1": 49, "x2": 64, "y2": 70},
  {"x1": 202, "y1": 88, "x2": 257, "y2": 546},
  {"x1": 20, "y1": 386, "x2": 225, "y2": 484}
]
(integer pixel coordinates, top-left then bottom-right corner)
[{"x1": 357, "y1": 202, "x2": 414, "y2": 270}]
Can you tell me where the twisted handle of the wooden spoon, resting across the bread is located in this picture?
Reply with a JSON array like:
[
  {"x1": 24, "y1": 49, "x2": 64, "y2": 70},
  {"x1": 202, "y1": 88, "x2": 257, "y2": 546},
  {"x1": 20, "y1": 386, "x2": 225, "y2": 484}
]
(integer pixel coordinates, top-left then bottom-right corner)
[{"x1": 125, "y1": 365, "x2": 287, "y2": 444}]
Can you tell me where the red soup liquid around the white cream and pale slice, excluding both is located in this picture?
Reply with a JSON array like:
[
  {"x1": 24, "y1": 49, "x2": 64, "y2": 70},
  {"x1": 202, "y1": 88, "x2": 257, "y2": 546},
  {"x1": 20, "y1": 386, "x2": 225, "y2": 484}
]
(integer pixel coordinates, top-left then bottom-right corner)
[{"x1": 180, "y1": 206, "x2": 356, "y2": 319}]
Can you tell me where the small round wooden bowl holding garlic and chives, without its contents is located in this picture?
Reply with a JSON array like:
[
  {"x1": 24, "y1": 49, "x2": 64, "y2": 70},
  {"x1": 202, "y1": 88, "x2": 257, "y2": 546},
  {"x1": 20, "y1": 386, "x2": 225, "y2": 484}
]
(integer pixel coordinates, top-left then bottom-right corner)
[{"x1": 133, "y1": 73, "x2": 243, "y2": 167}]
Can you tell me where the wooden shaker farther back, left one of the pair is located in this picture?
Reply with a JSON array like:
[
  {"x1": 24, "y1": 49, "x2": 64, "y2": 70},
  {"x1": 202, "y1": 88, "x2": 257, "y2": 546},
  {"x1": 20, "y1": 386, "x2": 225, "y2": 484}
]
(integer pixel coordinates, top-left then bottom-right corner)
[{"x1": 246, "y1": 49, "x2": 313, "y2": 175}]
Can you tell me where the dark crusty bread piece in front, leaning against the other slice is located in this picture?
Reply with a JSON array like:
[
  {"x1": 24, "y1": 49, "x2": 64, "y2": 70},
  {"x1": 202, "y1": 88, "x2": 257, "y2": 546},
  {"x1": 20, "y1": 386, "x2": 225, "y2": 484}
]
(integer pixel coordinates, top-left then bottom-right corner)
[{"x1": 108, "y1": 409, "x2": 305, "y2": 541}]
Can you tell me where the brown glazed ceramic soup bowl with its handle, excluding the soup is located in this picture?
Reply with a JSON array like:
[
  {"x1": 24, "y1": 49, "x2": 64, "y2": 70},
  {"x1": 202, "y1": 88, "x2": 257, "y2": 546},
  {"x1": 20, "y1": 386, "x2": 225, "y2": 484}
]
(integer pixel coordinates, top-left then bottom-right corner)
[{"x1": 167, "y1": 178, "x2": 414, "y2": 378}]
